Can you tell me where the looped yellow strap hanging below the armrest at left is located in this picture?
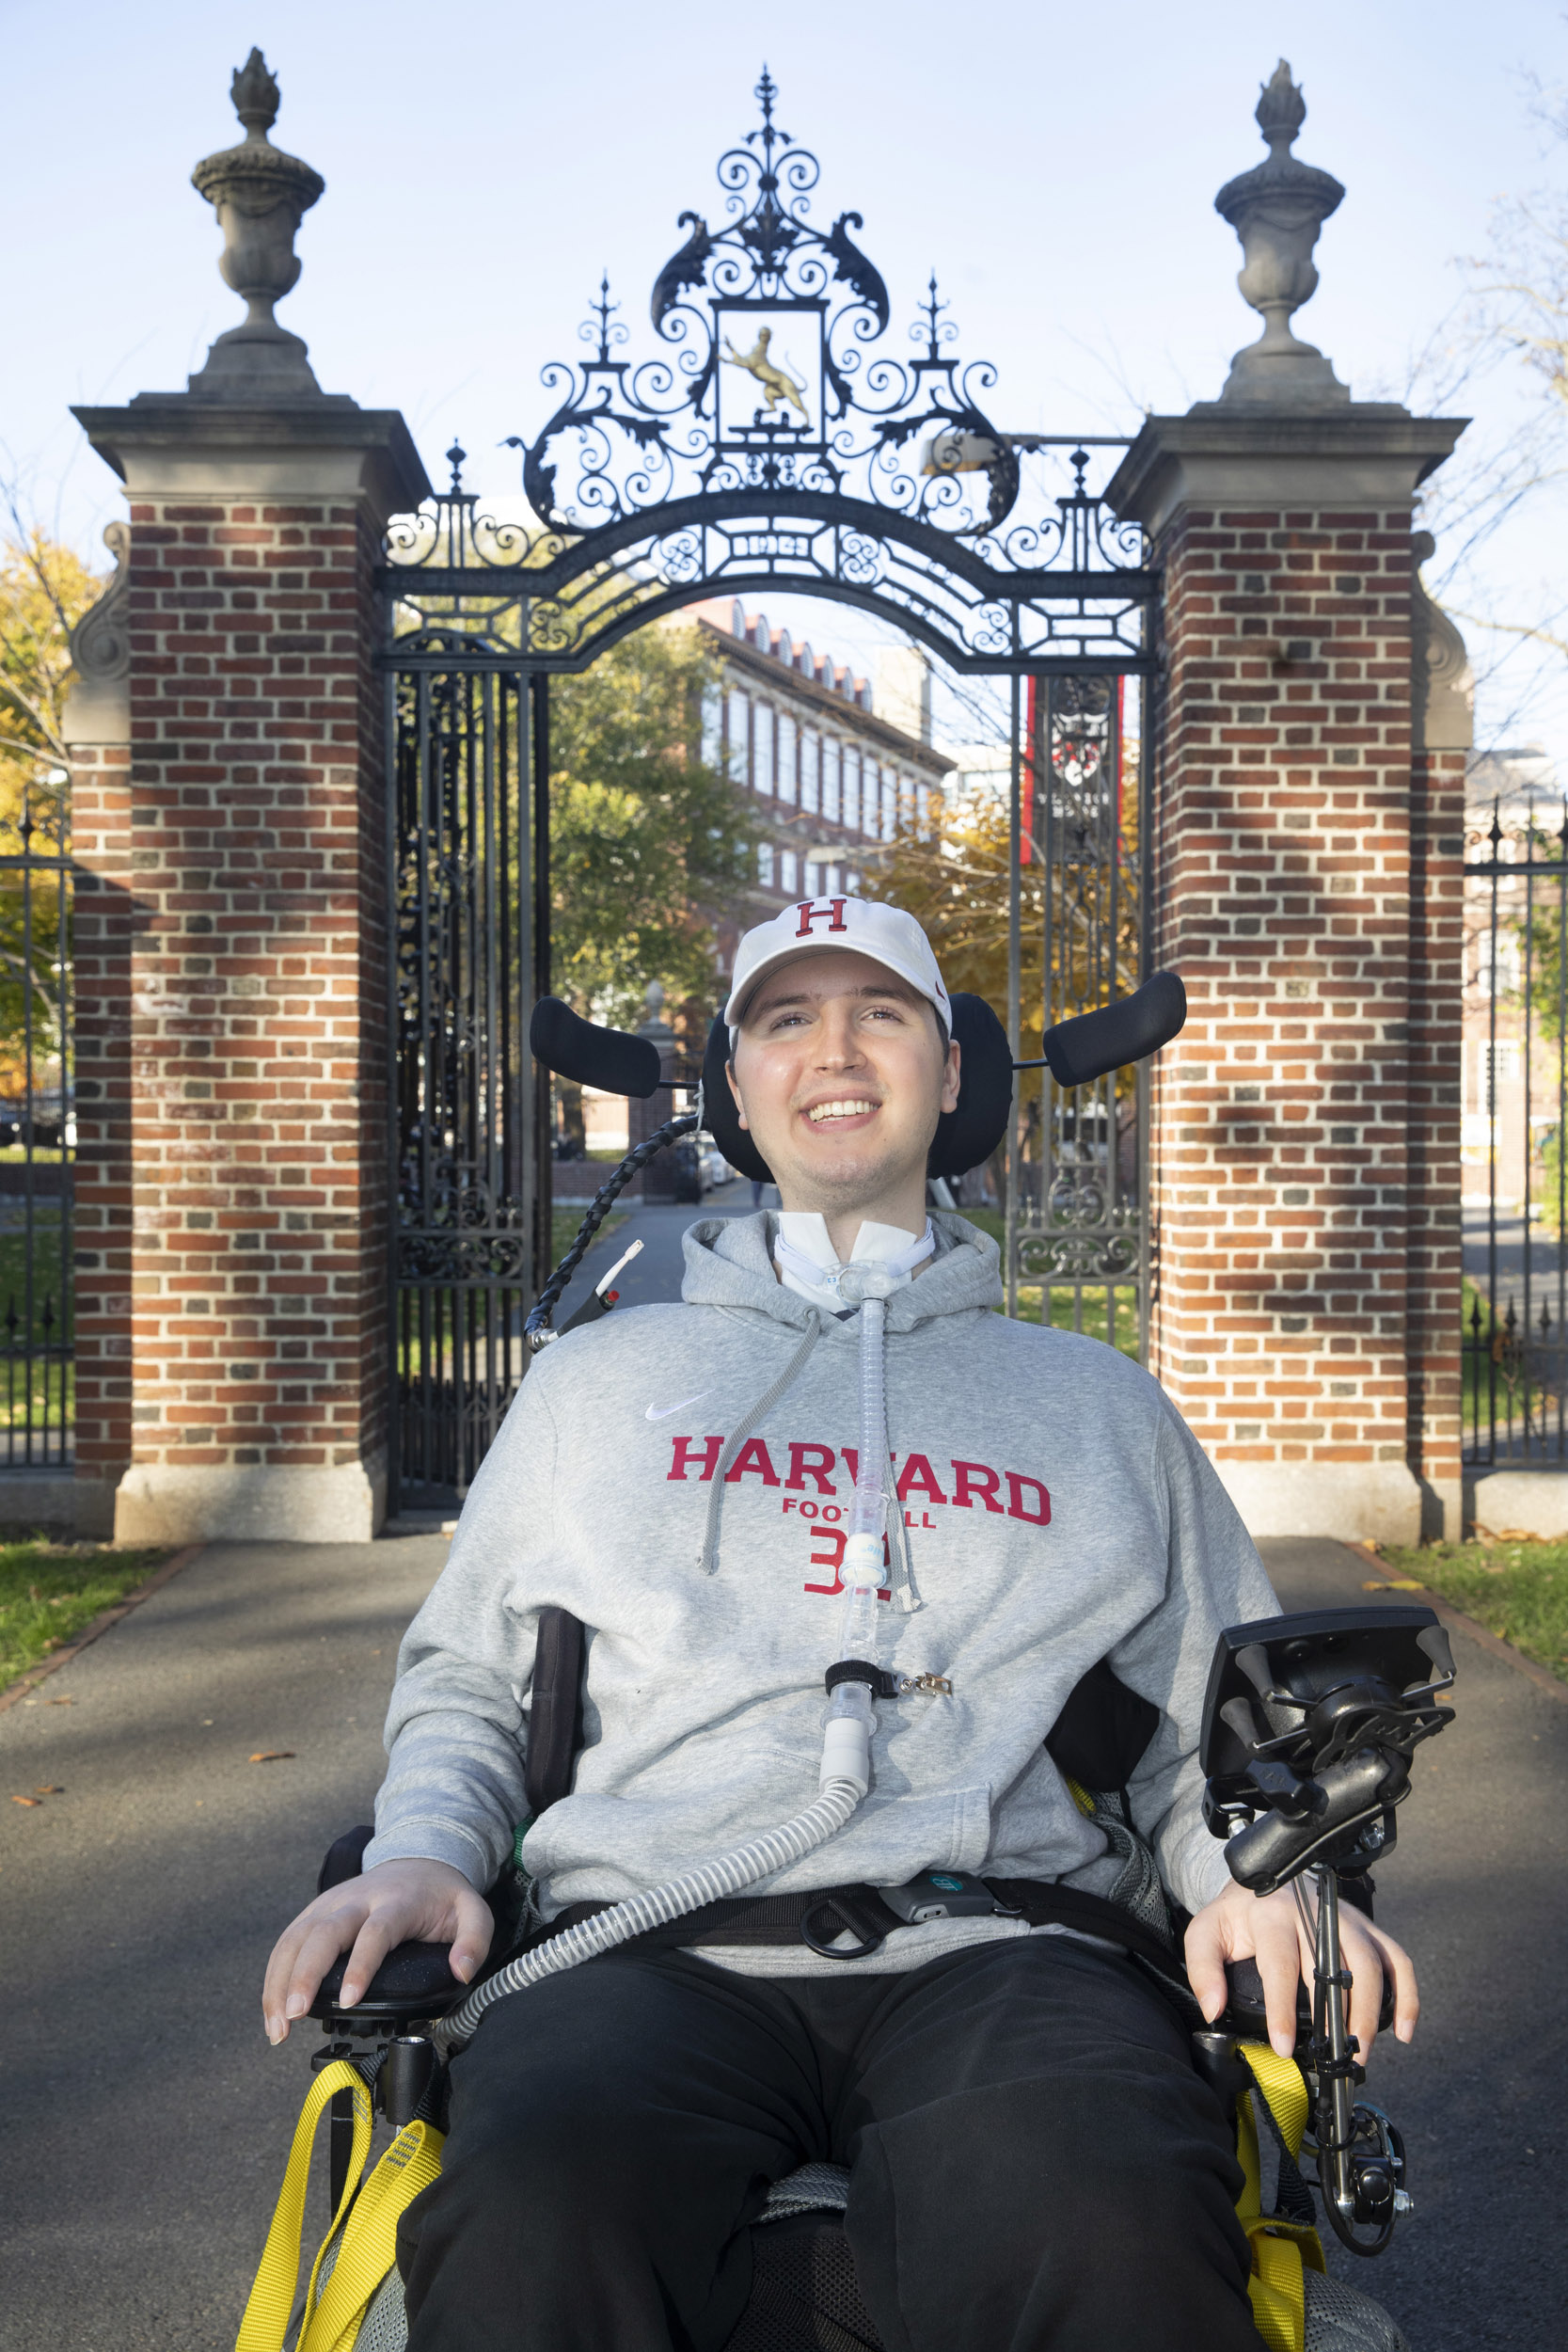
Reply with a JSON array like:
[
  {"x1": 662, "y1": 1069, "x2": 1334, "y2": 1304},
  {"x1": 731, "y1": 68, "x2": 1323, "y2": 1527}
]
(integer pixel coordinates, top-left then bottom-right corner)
[{"x1": 235, "y1": 2058, "x2": 442, "y2": 2352}]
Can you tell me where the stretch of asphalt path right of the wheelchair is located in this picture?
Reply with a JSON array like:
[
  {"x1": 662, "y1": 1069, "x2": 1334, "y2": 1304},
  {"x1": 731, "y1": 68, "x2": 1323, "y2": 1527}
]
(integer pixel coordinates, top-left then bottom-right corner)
[{"x1": 1260, "y1": 1541, "x2": 1568, "y2": 2352}]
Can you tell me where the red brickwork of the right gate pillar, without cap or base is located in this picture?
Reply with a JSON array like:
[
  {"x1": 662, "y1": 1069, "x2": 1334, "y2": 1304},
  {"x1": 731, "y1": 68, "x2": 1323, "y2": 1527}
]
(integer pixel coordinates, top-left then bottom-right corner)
[{"x1": 1152, "y1": 508, "x2": 1432, "y2": 1505}]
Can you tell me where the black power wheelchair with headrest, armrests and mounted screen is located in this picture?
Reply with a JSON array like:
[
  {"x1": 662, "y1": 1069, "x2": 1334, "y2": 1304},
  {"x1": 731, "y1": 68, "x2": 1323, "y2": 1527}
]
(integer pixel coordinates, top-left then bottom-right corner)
[{"x1": 242, "y1": 974, "x2": 1453, "y2": 2352}]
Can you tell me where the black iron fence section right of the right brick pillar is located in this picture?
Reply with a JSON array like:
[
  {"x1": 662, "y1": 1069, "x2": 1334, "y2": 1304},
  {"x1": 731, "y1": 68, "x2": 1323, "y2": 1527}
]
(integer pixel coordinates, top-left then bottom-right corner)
[{"x1": 1460, "y1": 795, "x2": 1568, "y2": 1468}]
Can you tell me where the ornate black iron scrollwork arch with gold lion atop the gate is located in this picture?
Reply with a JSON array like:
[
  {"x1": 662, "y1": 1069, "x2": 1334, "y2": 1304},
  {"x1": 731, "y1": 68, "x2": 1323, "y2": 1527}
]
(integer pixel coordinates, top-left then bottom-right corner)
[{"x1": 383, "y1": 71, "x2": 1154, "y2": 671}]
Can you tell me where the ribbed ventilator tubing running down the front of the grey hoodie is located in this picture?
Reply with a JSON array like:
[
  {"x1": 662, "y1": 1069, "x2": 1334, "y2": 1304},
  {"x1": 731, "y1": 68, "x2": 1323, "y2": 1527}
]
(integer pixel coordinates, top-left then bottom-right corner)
[{"x1": 435, "y1": 1298, "x2": 886, "y2": 2056}]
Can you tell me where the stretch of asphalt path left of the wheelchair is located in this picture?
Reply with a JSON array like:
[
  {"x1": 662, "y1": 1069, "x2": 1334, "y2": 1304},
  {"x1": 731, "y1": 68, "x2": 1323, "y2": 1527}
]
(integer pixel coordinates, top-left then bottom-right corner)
[{"x1": 0, "y1": 1538, "x2": 447, "y2": 2352}]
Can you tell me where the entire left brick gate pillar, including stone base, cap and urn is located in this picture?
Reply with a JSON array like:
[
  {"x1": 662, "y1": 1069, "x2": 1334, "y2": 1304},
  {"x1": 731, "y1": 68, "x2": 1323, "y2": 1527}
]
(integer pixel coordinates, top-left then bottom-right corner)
[{"x1": 68, "y1": 61, "x2": 430, "y2": 1543}]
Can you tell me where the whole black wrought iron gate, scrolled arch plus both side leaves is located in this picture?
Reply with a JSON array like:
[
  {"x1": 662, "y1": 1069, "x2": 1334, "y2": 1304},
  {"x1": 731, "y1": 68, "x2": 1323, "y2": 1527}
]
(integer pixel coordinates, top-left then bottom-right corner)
[{"x1": 378, "y1": 71, "x2": 1159, "y2": 1508}]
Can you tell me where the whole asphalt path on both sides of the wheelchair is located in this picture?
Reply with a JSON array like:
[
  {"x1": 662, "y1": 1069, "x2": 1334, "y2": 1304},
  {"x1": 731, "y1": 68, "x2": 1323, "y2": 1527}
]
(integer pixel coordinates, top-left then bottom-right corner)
[{"x1": 0, "y1": 1538, "x2": 1568, "y2": 2352}]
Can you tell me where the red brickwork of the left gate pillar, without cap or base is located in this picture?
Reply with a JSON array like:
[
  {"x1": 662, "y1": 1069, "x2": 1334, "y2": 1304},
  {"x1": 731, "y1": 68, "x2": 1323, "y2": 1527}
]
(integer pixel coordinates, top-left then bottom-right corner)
[{"x1": 75, "y1": 499, "x2": 388, "y2": 1505}]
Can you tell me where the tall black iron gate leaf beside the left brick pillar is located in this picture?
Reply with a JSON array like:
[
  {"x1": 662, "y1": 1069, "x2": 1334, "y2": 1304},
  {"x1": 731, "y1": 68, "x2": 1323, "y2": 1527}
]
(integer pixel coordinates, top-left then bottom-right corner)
[{"x1": 390, "y1": 626, "x2": 550, "y2": 1503}]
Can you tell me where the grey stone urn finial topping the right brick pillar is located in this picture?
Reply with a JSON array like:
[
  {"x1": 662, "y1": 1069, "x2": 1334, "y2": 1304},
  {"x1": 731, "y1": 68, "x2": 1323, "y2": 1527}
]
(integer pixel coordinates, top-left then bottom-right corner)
[{"x1": 1213, "y1": 56, "x2": 1350, "y2": 409}]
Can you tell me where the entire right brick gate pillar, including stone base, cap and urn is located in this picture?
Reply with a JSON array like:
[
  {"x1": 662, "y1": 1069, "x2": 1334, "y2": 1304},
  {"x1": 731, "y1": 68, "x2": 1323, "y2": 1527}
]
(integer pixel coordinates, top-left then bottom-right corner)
[{"x1": 1110, "y1": 69, "x2": 1463, "y2": 1541}]
